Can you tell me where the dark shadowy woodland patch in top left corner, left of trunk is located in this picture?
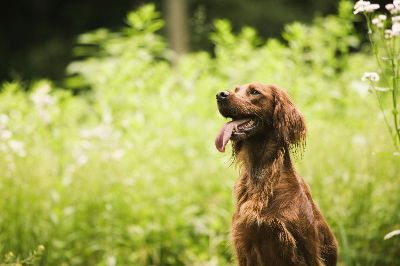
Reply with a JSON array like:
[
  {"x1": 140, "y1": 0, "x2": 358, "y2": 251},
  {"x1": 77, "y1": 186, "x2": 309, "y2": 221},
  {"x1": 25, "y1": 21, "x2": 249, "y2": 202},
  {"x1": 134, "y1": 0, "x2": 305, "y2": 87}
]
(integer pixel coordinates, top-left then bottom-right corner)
[{"x1": 0, "y1": 0, "x2": 137, "y2": 82}]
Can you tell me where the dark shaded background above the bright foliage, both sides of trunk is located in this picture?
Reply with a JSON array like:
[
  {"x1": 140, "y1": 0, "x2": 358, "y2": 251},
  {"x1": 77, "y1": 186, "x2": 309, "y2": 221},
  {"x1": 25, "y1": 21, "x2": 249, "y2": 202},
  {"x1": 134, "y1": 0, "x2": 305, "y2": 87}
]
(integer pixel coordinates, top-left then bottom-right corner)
[{"x1": 0, "y1": 0, "x2": 350, "y2": 81}]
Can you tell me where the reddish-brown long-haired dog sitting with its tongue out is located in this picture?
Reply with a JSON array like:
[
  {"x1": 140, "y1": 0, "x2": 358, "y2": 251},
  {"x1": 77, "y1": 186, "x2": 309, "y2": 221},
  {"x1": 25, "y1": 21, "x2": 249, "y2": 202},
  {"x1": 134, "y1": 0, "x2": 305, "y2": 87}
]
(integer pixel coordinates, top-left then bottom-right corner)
[{"x1": 215, "y1": 83, "x2": 337, "y2": 266}]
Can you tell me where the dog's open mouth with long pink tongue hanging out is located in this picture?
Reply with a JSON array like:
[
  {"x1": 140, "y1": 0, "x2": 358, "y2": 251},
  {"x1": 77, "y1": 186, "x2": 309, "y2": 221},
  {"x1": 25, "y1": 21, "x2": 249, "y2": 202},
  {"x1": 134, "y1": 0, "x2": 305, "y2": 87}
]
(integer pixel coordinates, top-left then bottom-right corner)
[{"x1": 215, "y1": 118, "x2": 257, "y2": 152}]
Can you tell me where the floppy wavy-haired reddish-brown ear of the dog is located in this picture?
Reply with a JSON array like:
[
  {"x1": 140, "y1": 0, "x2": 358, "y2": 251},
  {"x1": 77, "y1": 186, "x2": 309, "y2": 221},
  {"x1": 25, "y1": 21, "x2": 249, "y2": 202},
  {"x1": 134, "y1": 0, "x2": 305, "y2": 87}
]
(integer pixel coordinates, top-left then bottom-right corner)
[{"x1": 271, "y1": 87, "x2": 306, "y2": 151}]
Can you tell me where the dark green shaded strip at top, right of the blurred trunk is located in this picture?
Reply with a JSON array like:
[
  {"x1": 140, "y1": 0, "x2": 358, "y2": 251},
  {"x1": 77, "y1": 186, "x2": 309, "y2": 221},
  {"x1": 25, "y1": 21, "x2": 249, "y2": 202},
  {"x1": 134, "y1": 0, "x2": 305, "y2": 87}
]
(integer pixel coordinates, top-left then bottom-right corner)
[{"x1": 188, "y1": 0, "x2": 338, "y2": 50}]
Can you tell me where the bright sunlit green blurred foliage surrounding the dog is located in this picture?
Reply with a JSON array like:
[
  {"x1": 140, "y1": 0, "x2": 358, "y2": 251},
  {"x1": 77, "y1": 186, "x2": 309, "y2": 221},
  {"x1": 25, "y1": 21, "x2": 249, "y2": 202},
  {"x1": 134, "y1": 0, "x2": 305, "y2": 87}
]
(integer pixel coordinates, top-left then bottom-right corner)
[{"x1": 0, "y1": 1, "x2": 400, "y2": 265}]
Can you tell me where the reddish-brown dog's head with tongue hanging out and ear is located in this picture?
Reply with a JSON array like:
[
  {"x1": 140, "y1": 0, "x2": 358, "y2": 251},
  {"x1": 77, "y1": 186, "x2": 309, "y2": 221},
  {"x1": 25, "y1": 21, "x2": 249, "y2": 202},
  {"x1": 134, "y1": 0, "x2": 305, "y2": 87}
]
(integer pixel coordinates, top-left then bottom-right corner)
[{"x1": 215, "y1": 83, "x2": 306, "y2": 152}]
